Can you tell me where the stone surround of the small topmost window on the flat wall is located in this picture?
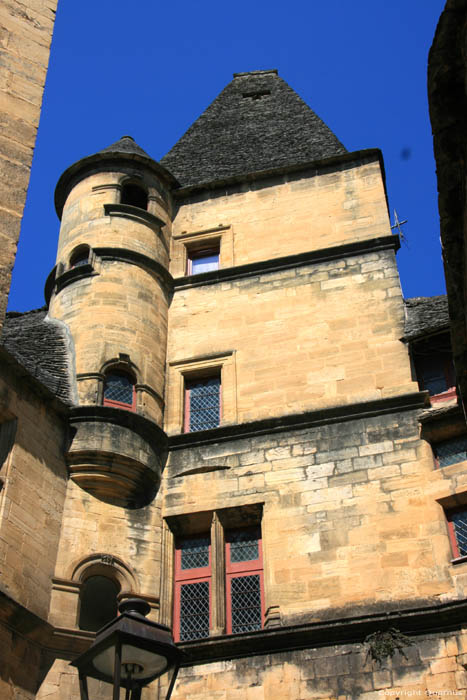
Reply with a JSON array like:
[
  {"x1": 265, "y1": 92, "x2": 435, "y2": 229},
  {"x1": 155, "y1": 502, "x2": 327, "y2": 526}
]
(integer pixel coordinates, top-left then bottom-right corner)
[{"x1": 171, "y1": 224, "x2": 235, "y2": 277}]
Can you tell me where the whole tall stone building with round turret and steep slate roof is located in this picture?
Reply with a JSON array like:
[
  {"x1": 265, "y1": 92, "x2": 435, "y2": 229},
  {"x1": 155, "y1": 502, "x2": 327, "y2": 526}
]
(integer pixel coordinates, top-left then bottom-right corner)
[{"x1": 0, "y1": 71, "x2": 467, "y2": 700}]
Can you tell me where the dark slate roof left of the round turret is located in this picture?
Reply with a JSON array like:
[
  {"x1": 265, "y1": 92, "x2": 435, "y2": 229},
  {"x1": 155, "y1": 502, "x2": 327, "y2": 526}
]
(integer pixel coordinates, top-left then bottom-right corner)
[{"x1": 1, "y1": 307, "x2": 71, "y2": 403}]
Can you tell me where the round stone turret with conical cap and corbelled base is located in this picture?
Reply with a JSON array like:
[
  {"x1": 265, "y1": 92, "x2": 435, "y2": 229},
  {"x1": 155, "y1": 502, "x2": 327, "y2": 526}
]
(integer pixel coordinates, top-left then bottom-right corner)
[{"x1": 46, "y1": 136, "x2": 176, "y2": 506}]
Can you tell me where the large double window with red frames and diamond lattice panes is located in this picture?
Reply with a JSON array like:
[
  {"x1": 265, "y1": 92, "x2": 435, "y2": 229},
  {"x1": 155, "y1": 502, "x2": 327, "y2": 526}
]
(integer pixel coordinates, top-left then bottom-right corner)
[{"x1": 174, "y1": 526, "x2": 264, "y2": 642}]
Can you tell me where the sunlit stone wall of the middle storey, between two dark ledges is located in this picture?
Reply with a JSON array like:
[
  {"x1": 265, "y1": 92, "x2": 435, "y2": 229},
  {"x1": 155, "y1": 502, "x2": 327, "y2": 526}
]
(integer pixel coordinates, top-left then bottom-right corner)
[{"x1": 165, "y1": 249, "x2": 417, "y2": 434}]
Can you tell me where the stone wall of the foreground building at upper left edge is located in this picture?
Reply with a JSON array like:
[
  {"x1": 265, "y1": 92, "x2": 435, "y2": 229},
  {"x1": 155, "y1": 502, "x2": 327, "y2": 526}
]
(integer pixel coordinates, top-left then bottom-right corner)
[{"x1": 0, "y1": 0, "x2": 57, "y2": 326}]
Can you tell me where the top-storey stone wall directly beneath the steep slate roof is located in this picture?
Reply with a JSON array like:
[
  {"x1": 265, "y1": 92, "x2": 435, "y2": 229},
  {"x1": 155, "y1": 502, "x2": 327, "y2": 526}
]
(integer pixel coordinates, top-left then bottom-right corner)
[{"x1": 171, "y1": 153, "x2": 390, "y2": 276}]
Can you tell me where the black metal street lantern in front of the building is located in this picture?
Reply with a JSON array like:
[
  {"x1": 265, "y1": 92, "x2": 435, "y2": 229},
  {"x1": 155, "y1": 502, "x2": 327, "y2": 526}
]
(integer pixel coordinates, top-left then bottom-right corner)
[{"x1": 71, "y1": 598, "x2": 182, "y2": 700}]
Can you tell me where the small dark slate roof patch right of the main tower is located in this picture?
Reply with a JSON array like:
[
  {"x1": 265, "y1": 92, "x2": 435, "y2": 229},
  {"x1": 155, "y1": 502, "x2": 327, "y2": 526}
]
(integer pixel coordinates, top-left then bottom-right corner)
[{"x1": 404, "y1": 294, "x2": 449, "y2": 341}]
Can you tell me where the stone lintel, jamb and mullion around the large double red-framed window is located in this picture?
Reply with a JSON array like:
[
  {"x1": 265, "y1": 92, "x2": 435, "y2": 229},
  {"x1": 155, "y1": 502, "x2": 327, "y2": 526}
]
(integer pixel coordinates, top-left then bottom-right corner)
[{"x1": 160, "y1": 502, "x2": 266, "y2": 637}]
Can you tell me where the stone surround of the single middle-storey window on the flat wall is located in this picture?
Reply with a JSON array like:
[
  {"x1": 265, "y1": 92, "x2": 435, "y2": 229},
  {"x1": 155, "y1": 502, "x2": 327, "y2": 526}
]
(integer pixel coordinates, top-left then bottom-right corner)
[{"x1": 166, "y1": 350, "x2": 237, "y2": 434}]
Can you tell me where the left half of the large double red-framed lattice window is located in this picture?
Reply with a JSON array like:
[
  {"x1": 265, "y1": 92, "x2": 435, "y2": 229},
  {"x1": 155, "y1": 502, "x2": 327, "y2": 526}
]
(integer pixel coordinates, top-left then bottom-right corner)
[{"x1": 174, "y1": 535, "x2": 211, "y2": 642}]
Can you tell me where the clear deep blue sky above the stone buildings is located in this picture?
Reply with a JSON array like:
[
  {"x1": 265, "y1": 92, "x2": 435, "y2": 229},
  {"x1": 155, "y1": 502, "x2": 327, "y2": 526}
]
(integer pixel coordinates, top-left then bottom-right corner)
[{"x1": 9, "y1": 0, "x2": 445, "y2": 311}]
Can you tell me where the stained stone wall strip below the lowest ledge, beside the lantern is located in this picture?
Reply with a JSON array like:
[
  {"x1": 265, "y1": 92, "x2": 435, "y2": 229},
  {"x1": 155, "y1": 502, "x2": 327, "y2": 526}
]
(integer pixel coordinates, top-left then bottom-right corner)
[{"x1": 173, "y1": 631, "x2": 467, "y2": 700}]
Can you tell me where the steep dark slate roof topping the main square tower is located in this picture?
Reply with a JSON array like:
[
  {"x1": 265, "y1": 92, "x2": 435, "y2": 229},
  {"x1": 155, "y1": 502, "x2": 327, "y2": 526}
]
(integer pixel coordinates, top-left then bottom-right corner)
[{"x1": 161, "y1": 70, "x2": 347, "y2": 187}]
